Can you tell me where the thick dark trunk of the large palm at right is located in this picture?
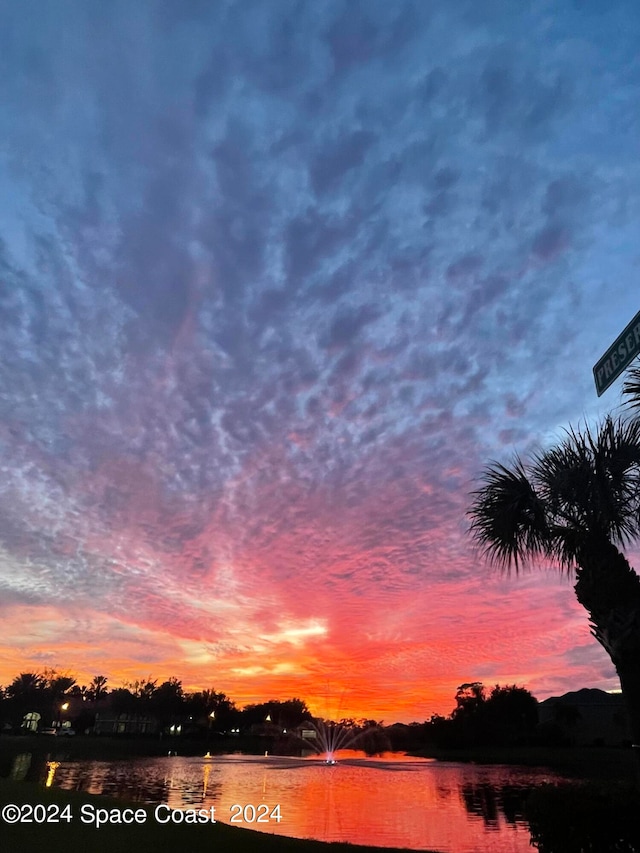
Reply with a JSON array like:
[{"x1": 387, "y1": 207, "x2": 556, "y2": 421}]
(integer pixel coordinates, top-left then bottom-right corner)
[{"x1": 574, "y1": 541, "x2": 640, "y2": 773}]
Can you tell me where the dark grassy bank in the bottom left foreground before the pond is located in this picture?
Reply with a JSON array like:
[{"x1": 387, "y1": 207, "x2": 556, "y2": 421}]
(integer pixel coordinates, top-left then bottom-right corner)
[{"x1": 0, "y1": 779, "x2": 424, "y2": 853}]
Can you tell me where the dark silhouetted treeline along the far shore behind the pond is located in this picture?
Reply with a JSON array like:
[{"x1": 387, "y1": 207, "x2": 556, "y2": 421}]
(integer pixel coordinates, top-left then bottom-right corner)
[{"x1": 0, "y1": 670, "x2": 538, "y2": 751}]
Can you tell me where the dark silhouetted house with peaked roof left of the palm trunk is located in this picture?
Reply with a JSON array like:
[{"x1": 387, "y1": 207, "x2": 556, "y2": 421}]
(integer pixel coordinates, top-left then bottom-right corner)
[{"x1": 538, "y1": 687, "x2": 631, "y2": 746}]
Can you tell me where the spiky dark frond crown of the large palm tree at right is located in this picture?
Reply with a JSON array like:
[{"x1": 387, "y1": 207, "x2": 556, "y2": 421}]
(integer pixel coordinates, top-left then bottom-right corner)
[{"x1": 468, "y1": 410, "x2": 640, "y2": 571}]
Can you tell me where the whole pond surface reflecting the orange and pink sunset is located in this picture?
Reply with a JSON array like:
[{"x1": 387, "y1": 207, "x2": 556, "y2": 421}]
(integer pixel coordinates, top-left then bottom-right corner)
[{"x1": 2, "y1": 752, "x2": 558, "y2": 853}]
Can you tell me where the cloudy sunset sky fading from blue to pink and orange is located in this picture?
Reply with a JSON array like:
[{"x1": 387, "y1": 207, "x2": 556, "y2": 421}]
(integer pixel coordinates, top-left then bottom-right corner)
[{"x1": 0, "y1": 0, "x2": 640, "y2": 722}]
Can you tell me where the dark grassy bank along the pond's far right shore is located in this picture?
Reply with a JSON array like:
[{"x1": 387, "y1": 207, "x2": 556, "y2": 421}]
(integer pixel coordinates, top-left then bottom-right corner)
[{"x1": 414, "y1": 746, "x2": 637, "y2": 781}]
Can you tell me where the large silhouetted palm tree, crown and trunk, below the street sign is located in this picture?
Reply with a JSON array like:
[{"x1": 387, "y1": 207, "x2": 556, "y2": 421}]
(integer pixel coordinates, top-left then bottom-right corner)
[{"x1": 469, "y1": 416, "x2": 640, "y2": 759}]
